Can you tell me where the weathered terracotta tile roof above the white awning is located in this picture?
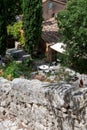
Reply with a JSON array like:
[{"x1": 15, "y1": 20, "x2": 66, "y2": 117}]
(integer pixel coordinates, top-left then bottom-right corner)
[{"x1": 42, "y1": 18, "x2": 60, "y2": 44}]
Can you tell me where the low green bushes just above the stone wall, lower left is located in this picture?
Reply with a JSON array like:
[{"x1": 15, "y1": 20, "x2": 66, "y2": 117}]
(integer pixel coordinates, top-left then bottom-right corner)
[{"x1": 0, "y1": 61, "x2": 32, "y2": 80}]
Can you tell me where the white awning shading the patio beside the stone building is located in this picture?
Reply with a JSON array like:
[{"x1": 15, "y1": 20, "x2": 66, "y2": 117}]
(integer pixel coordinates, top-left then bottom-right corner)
[{"x1": 50, "y1": 43, "x2": 65, "y2": 54}]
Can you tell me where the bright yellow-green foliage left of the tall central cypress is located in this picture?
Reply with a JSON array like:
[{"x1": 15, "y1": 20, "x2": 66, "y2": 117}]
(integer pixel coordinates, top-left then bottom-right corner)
[{"x1": 7, "y1": 21, "x2": 25, "y2": 46}]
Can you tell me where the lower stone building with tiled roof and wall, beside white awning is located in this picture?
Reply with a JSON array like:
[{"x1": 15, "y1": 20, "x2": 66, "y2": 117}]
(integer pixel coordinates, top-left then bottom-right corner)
[{"x1": 38, "y1": 18, "x2": 60, "y2": 62}]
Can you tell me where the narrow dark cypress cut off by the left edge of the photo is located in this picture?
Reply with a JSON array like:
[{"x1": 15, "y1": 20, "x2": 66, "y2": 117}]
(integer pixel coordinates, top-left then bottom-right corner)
[{"x1": 0, "y1": 0, "x2": 7, "y2": 55}]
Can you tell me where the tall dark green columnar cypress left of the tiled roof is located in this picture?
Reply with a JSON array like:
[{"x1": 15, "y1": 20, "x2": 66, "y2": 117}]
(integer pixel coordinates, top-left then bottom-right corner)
[{"x1": 23, "y1": 0, "x2": 42, "y2": 53}]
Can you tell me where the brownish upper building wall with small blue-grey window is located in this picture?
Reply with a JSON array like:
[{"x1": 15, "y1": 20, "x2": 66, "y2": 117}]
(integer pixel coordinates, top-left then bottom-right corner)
[{"x1": 43, "y1": 0, "x2": 65, "y2": 20}]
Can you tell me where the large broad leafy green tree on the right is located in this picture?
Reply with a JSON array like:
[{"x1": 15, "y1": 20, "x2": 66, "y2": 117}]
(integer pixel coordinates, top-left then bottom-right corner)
[{"x1": 57, "y1": 0, "x2": 87, "y2": 68}]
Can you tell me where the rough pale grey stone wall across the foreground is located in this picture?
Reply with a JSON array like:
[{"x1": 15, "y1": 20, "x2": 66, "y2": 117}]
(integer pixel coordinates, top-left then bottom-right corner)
[{"x1": 0, "y1": 77, "x2": 87, "y2": 130}]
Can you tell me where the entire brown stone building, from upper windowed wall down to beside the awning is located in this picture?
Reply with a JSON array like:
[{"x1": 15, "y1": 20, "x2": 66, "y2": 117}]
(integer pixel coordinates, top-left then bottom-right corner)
[{"x1": 38, "y1": 0, "x2": 67, "y2": 62}]
